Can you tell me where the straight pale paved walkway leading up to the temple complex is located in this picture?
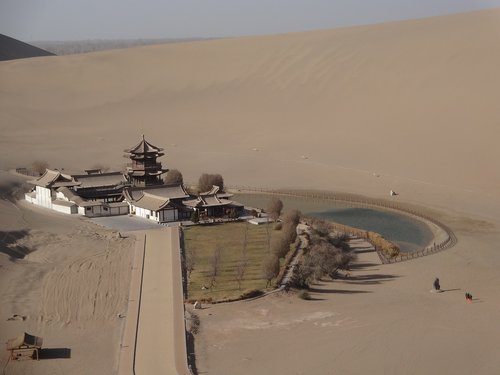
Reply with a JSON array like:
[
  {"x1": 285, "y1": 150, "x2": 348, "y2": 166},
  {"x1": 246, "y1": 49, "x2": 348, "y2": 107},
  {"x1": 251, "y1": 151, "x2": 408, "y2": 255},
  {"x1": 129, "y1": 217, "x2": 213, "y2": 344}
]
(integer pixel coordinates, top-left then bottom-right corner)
[{"x1": 119, "y1": 228, "x2": 190, "y2": 375}]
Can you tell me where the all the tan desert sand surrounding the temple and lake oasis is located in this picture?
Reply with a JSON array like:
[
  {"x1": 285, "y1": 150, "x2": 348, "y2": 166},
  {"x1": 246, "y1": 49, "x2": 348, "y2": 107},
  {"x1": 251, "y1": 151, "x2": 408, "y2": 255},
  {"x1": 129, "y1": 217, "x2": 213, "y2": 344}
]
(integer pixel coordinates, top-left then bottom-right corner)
[{"x1": 0, "y1": 9, "x2": 500, "y2": 375}]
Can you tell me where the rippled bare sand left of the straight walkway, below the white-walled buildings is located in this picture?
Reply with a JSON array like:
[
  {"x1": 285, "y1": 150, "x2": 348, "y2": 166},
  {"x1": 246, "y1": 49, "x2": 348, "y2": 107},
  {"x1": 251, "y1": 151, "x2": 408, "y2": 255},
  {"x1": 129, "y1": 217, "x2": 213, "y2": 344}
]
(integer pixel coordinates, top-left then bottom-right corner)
[{"x1": 0, "y1": 172, "x2": 134, "y2": 374}]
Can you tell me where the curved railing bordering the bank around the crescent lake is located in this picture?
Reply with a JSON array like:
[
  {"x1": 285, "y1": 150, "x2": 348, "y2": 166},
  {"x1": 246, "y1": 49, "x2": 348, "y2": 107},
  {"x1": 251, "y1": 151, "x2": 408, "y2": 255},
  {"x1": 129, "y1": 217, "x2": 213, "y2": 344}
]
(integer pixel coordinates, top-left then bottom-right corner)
[{"x1": 226, "y1": 185, "x2": 458, "y2": 263}]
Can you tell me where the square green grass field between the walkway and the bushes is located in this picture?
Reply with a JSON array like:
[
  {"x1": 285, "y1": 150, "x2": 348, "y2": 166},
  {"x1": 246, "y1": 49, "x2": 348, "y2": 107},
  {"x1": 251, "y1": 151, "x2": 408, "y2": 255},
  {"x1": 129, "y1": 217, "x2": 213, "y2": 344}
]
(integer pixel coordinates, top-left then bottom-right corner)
[{"x1": 184, "y1": 223, "x2": 282, "y2": 301}]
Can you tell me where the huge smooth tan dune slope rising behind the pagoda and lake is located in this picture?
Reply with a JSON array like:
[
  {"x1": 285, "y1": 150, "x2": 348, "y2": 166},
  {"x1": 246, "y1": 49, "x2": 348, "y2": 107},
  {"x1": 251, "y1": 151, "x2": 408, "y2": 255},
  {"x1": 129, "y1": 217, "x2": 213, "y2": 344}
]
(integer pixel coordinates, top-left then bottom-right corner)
[{"x1": 0, "y1": 10, "x2": 500, "y2": 212}]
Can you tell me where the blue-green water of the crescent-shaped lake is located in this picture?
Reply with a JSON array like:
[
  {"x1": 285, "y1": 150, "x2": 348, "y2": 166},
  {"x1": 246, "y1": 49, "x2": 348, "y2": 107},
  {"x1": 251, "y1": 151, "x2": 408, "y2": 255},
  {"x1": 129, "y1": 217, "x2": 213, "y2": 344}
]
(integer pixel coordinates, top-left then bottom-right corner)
[{"x1": 234, "y1": 194, "x2": 433, "y2": 252}]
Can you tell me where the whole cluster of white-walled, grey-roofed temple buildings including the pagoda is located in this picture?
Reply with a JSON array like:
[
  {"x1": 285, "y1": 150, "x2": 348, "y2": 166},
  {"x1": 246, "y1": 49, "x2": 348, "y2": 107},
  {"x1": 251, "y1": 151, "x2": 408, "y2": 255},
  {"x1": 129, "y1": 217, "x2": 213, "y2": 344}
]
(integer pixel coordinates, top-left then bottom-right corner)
[{"x1": 25, "y1": 135, "x2": 244, "y2": 224}]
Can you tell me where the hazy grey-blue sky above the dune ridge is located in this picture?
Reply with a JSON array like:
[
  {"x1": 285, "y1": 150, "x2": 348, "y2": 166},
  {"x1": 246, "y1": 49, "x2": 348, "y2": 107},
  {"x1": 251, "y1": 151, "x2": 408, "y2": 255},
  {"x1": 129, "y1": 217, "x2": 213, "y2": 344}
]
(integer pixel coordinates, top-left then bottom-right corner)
[{"x1": 0, "y1": 0, "x2": 500, "y2": 41}]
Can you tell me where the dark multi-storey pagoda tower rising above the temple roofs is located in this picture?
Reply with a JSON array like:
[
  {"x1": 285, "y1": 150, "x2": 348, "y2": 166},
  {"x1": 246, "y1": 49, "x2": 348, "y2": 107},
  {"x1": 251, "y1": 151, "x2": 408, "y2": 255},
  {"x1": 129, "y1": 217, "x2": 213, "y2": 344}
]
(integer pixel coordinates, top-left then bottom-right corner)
[{"x1": 124, "y1": 135, "x2": 168, "y2": 186}]
